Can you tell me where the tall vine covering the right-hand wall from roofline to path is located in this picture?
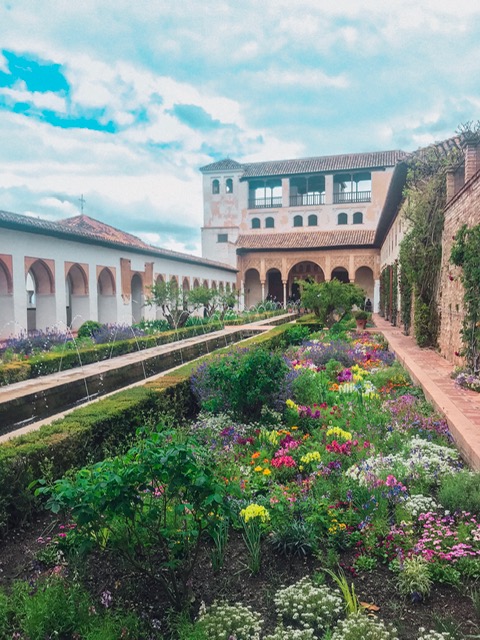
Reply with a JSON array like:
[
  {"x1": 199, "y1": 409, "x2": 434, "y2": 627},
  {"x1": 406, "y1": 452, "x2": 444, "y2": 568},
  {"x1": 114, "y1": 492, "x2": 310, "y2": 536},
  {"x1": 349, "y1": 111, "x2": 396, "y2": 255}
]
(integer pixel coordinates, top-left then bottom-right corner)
[{"x1": 400, "y1": 147, "x2": 458, "y2": 347}]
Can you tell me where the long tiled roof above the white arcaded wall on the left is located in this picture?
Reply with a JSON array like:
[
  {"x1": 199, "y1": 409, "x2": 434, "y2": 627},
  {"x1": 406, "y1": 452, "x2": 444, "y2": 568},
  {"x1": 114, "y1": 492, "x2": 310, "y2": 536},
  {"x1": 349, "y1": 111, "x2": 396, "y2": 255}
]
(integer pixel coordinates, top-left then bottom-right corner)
[{"x1": 0, "y1": 210, "x2": 237, "y2": 271}]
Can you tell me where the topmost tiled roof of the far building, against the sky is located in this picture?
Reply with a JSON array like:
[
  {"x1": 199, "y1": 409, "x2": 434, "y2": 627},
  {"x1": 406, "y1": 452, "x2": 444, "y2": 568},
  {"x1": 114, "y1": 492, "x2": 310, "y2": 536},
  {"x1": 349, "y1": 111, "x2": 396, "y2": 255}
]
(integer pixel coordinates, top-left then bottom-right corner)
[{"x1": 200, "y1": 150, "x2": 406, "y2": 179}]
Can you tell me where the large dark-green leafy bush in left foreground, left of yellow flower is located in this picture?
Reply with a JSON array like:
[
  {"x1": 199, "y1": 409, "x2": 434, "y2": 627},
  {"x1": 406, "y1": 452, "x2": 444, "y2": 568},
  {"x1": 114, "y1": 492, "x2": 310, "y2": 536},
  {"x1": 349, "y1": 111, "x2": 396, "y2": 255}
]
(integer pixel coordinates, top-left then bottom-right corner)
[{"x1": 37, "y1": 432, "x2": 231, "y2": 608}]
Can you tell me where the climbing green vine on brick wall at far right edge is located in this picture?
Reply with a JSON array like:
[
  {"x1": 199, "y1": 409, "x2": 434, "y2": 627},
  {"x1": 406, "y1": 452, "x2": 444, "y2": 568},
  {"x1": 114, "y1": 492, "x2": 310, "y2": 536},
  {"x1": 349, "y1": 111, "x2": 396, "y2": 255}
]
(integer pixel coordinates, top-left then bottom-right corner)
[{"x1": 450, "y1": 225, "x2": 480, "y2": 374}]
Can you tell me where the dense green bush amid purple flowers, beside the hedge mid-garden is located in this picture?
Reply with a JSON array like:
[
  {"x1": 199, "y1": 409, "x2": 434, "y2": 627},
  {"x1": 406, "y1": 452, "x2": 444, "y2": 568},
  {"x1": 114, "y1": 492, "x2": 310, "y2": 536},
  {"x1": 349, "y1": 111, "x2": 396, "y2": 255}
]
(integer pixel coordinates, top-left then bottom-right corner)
[{"x1": 192, "y1": 348, "x2": 288, "y2": 421}]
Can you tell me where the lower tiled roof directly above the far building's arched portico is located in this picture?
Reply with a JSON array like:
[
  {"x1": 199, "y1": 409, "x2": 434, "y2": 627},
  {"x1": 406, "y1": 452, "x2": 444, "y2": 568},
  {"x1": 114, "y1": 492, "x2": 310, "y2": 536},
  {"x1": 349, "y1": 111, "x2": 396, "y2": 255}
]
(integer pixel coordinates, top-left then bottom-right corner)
[{"x1": 237, "y1": 229, "x2": 375, "y2": 249}]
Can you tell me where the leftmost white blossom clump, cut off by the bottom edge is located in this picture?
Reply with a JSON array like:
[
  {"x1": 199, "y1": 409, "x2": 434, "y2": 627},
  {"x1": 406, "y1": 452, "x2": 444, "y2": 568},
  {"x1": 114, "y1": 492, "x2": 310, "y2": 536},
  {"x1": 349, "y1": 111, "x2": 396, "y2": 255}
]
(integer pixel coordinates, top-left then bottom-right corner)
[{"x1": 198, "y1": 602, "x2": 263, "y2": 640}]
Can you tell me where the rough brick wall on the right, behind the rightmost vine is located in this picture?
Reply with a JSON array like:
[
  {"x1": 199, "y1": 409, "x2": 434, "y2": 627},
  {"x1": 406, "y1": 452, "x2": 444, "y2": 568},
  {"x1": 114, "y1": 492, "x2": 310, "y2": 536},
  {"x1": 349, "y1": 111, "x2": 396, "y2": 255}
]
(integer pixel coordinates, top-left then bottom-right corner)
[{"x1": 439, "y1": 172, "x2": 480, "y2": 365}]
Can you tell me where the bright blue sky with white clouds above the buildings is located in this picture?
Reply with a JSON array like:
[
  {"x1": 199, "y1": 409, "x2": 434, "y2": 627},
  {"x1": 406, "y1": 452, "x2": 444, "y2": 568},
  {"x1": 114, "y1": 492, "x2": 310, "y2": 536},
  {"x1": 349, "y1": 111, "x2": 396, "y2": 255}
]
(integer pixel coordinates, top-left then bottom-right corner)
[{"x1": 0, "y1": 0, "x2": 480, "y2": 255}]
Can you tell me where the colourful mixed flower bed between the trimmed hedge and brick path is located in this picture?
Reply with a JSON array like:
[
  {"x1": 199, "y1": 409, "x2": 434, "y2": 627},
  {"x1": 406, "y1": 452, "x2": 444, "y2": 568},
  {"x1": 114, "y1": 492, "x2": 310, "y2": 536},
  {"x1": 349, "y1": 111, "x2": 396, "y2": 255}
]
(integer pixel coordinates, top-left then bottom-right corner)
[{"x1": 1, "y1": 334, "x2": 480, "y2": 640}]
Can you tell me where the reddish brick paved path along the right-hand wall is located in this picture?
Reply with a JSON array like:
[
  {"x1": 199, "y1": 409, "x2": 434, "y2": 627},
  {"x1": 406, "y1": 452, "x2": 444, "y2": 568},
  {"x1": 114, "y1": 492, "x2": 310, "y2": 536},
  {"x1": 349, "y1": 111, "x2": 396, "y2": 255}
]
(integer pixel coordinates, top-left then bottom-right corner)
[{"x1": 373, "y1": 315, "x2": 480, "y2": 471}]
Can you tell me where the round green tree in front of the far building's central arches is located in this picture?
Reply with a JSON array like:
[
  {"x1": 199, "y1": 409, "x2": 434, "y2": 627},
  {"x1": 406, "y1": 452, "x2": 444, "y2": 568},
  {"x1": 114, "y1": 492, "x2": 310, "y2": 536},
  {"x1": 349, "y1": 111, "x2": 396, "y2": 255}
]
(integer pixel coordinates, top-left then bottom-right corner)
[{"x1": 298, "y1": 278, "x2": 366, "y2": 327}]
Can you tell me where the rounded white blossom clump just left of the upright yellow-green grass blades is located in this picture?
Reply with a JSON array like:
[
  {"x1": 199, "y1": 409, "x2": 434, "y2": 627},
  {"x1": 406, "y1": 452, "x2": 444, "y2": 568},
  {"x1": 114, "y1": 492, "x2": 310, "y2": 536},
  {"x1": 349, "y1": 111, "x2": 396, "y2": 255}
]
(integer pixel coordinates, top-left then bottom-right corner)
[{"x1": 274, "y1": 577, "x2": 343, "y2": 631}]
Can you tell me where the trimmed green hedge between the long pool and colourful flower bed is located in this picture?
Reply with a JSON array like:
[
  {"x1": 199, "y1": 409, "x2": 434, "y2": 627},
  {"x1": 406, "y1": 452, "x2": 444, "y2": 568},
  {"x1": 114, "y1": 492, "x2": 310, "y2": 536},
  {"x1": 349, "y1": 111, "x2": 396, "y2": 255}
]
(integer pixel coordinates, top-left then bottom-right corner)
[{"x1": 0, "y1": 323, "x2": 292, "y2": 536}]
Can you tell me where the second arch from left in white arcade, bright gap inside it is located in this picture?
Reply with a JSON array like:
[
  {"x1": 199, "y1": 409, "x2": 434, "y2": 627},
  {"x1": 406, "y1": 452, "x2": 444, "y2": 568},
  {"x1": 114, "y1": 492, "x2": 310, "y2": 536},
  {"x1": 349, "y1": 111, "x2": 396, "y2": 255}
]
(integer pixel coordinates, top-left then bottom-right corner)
[{"x1": 26, "y1": 260, "x2": 57, "y2": 331}]
